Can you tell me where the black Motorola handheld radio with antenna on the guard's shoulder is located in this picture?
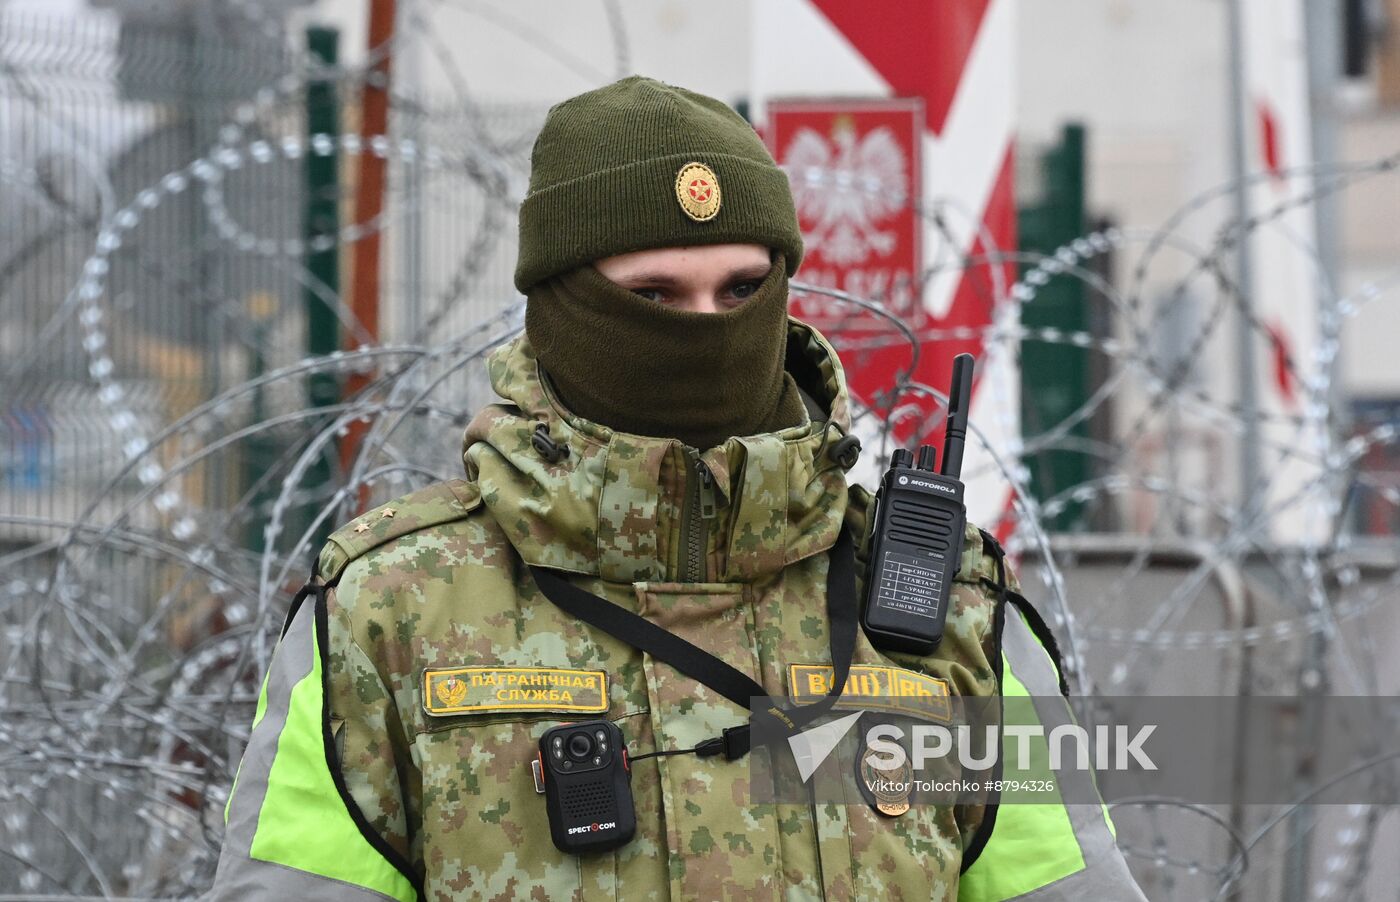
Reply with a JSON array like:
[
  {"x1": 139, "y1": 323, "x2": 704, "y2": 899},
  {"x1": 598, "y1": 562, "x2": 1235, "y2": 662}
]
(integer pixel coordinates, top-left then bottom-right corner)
[{"x1": 861, "y1": 354, "x2": 973, "y2": 654}]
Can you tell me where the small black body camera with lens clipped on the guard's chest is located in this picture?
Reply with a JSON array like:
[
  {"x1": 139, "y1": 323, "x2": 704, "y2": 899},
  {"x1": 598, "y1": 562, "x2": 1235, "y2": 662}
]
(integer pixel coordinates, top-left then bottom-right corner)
[{"x1": 532, "y1": 720, "x2": 637, "y2": 854}]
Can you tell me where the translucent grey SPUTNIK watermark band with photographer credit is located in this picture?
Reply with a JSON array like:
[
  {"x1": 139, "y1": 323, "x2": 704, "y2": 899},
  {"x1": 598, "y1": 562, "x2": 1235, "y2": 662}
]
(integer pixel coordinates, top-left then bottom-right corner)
[{"x1": 750, "y1": 694, "x2": 1400, "y2": 817}]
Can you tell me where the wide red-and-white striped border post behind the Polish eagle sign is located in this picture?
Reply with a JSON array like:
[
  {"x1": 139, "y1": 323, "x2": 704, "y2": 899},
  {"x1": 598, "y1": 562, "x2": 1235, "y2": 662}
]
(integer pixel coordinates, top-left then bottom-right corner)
[{"x1": 750, "y1": 0, "x2": 1021, "y2": 536}]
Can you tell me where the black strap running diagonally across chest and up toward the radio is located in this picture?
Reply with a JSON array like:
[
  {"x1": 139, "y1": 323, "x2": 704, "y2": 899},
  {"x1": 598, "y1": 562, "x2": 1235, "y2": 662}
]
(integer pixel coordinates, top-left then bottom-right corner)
[{"x1": 531, "y1": 527, "x2": 857, "y2": 759}]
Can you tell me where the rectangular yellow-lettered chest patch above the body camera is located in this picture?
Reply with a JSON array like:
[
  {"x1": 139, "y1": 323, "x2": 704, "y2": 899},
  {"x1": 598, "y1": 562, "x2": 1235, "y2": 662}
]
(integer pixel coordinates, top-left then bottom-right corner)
[{"x1": 423, "y1": 667, "x2": 608, "y2": 717}]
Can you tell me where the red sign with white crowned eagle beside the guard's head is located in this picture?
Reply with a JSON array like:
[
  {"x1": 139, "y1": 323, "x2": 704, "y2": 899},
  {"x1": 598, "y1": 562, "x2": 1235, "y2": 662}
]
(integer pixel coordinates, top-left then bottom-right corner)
[{"x1": 767, "y1": 99, "x2": 924, "y2": 331}]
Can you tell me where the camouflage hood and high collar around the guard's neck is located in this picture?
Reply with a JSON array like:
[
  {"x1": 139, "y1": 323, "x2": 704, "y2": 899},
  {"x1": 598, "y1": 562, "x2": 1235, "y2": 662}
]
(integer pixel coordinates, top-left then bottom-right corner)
[{"x1": 462, "y1": 317, "x2": 850, "y2": 583}]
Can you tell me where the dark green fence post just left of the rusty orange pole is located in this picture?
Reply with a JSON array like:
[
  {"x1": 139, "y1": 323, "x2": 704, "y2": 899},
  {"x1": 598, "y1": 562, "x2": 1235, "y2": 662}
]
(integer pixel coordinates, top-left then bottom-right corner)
[{"x1": 301, "y1": 25, "x2": 340, "y2": 545}]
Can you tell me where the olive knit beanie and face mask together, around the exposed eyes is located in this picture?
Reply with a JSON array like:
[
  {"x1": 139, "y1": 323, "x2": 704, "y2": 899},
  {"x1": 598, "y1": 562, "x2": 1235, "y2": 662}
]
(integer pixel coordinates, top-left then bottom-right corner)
[{"x1": 515, "y1": 77, "x2": 805, "y2": 448}]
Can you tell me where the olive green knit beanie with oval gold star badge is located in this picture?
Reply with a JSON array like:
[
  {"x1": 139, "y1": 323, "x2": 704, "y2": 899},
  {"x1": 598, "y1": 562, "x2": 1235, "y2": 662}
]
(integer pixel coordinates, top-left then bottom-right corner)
[{"x1": 515, "y1": 76, "x2": 802, "y2": 294}]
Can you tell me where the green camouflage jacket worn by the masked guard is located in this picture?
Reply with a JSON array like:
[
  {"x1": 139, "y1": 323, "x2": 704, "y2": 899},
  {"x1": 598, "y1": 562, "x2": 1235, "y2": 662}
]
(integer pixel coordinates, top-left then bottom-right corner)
[{"x1": 214, "y1": 321, "x2": 1052, "y2": 901}]
